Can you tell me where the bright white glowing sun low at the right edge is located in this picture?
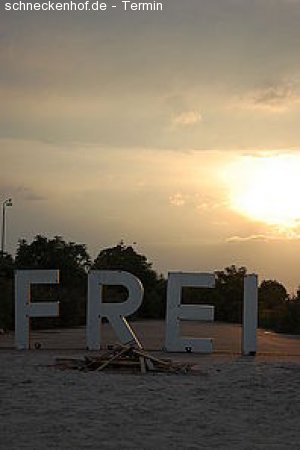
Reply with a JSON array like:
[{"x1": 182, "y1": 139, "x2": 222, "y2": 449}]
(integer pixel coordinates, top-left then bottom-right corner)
[{"x1": 227, "y1": 155, "x2": 300, "y2": 228}]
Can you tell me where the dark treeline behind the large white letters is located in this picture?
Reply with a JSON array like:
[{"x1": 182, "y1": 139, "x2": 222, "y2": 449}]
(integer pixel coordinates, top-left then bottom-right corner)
[{"x1": 0, "y1": 235, "x2": 300, "y2": 334}]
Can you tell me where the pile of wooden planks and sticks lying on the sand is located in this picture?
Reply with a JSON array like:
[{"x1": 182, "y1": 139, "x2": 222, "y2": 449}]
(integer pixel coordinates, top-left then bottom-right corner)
[{"x1": 55, "y1": 345, "x2": 191, "y2": 373}]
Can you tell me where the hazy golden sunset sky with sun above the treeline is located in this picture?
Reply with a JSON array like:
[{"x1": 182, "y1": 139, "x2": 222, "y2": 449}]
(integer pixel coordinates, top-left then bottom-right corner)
[{"x1": 0, "y1": 0, "x2": 300, "y2": 293}]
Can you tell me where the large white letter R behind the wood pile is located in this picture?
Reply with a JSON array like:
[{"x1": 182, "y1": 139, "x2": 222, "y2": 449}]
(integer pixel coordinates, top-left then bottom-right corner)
[{"x1": 87, "y1": 270, "x2": 144, "y2": 350}]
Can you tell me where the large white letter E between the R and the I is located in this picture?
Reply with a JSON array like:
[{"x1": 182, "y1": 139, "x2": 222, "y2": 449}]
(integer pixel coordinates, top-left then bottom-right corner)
[{"x1": 165, "y1": 272, "x2": 215, "y2": 353}]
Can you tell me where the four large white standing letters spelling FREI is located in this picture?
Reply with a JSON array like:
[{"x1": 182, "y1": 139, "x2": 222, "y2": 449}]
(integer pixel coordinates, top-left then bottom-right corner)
[{"x1": 15, "y1": 270, "x2": 258, "y2": 355}]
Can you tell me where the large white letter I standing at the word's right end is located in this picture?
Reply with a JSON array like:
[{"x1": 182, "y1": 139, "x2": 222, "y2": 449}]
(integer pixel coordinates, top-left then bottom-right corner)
[{"x1": 242, "y1": 274, "x2": 258, "y2": 356}]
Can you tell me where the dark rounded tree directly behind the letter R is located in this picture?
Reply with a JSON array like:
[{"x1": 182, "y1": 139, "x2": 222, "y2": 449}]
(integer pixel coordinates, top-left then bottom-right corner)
[{"x1": 93, "y1": 241, "x2": 166, "y2": 318}]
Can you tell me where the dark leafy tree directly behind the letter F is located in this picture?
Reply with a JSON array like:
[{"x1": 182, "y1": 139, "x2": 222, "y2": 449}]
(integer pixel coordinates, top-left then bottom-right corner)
[{"x1": 15, "y1": 235, "x2": 90, "y2": 326}]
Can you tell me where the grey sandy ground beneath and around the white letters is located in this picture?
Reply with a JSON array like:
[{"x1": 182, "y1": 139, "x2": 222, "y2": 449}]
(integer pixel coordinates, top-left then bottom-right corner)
[{"x1": 0, "y1": 322, "x2": 300, "y2": 450}]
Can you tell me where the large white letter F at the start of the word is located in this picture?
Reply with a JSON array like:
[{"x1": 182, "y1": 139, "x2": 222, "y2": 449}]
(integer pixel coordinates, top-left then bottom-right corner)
[{"x1": 15, "y1": 270, "x2": 59, "y2": 350}]
